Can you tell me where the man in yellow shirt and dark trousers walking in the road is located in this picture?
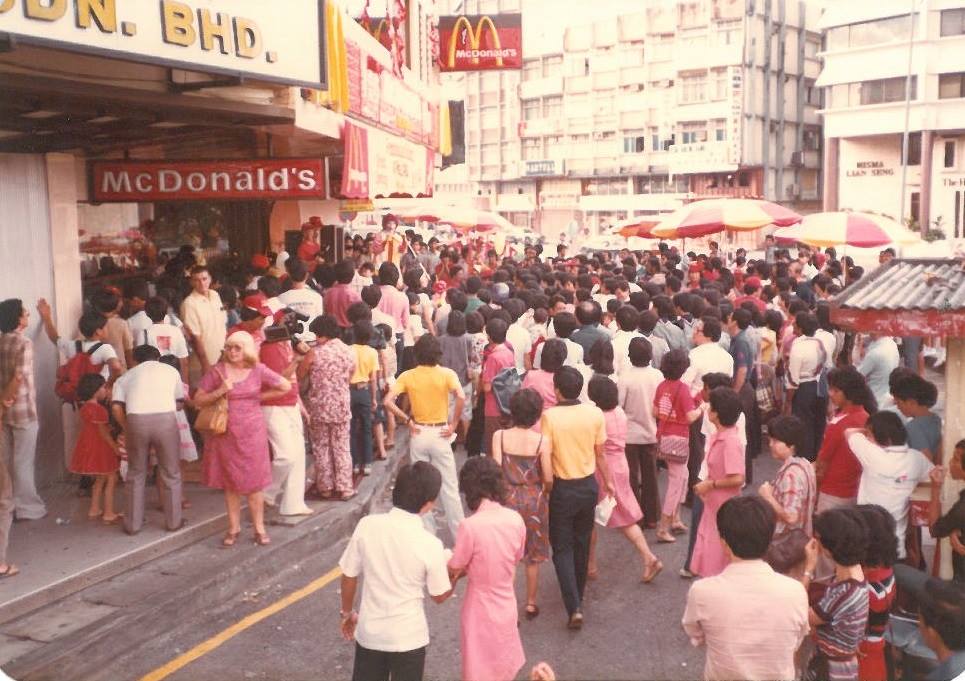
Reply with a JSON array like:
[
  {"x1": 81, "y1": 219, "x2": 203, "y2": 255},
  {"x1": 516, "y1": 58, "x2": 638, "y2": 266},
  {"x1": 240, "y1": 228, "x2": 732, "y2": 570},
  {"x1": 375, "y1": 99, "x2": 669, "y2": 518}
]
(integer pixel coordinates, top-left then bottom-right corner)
[{"x1": 541, "y1": 367, "x2": 613, "y2": 629}]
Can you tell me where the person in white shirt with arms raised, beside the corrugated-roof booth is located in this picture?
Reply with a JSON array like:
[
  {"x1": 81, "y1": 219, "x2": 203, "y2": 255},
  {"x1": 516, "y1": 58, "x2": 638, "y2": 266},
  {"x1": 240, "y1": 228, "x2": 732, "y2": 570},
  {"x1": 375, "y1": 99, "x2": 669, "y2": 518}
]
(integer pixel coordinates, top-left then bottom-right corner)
[{"x1": 844, "y1": 411, "x2": 935, "y2": 558}]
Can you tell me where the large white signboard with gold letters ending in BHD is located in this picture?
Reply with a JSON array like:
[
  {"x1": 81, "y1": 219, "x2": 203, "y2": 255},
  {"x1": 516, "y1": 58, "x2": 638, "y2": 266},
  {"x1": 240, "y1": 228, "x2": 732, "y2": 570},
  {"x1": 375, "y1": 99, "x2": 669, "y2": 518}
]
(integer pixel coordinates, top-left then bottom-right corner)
[{"x1": 0, "y1": 0, "x2": 326, "y2": 88}]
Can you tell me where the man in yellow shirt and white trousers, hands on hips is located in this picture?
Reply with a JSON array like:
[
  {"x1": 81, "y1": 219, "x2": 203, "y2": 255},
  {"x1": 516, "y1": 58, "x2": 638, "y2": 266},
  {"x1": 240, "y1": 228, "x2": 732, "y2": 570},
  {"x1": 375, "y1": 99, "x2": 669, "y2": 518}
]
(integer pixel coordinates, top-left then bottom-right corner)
[{"x1": 384, "y1": 333, "x2": 466, "y2": 541}]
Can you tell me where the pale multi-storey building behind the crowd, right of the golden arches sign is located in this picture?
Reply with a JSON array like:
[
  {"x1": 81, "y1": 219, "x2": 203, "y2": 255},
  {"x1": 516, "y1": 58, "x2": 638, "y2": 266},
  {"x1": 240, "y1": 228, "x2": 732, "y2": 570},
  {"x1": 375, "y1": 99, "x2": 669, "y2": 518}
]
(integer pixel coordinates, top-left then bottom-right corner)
[{"x1": 460, "y1": 0, "x2": 821, "y2": 235}]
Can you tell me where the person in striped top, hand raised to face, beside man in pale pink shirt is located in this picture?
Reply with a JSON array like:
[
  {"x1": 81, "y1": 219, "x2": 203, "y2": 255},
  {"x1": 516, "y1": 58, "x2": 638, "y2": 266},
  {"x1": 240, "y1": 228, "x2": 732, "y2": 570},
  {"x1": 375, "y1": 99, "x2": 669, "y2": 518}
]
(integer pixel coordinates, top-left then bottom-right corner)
[{"x1": 801, "y1": 508, "x2": 868, "y2": 681}]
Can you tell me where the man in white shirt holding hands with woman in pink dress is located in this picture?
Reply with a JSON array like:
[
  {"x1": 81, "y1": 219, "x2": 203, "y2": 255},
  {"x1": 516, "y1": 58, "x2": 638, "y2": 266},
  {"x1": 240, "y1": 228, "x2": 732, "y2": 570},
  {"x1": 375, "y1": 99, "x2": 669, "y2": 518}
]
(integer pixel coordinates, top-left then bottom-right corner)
[{"x1": 339, "y1": 461, "x2": 452, "y2": 681}]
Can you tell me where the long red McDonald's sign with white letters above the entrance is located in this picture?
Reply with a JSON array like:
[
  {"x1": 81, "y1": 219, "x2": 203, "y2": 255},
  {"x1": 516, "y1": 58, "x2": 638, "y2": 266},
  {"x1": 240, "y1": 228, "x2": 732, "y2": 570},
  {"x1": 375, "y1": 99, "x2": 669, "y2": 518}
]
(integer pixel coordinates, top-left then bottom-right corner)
[{"x1": 89, "y1": 158, "x2": 325, "y2": 203}]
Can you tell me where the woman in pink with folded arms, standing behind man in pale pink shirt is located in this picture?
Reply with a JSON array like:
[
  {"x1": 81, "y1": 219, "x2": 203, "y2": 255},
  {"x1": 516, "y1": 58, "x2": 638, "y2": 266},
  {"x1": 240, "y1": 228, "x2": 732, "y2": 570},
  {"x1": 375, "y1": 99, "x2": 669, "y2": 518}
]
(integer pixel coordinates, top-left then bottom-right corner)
[{"x1": 690, "y1": 388, "x2": 744, "y2": 577}]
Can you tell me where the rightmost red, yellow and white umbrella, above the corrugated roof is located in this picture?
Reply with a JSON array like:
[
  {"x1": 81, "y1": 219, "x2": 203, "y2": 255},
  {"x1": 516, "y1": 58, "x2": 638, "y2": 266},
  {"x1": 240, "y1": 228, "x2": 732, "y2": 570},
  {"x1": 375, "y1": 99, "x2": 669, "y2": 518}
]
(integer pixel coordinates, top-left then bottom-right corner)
[{"x1": 774, "y1": 211, "x2": 921, "y2": 248}]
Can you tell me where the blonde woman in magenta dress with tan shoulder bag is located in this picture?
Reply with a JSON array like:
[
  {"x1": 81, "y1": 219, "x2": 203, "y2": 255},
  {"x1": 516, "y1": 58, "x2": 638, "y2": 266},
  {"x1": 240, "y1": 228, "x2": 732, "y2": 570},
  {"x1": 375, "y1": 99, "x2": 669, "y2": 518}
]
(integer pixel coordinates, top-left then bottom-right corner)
[{"x1": 194, "y1": 331, "x2": 291, "y2": 546}]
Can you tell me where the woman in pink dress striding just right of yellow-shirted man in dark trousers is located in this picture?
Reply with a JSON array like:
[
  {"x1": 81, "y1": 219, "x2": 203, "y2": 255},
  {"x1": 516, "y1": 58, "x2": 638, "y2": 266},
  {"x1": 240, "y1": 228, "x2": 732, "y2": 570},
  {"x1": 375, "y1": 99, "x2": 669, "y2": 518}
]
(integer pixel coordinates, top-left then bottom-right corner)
[{"x1": 587, "y1": 376, "x2": 663, "y2": 584}]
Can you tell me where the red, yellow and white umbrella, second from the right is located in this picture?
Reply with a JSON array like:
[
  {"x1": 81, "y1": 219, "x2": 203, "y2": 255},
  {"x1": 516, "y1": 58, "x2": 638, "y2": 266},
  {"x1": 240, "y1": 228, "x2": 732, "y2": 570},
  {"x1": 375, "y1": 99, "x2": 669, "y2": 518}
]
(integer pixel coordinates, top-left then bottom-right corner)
[{"x1": 652, "y1": 199, "x2": 801, "y2": 239}]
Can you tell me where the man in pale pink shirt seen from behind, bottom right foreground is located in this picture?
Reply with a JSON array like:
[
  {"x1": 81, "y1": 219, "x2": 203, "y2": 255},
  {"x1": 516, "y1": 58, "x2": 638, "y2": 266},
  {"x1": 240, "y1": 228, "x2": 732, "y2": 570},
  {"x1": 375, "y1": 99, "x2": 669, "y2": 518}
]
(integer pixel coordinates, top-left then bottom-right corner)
[{"x1": 681, "y1": 496, "x2": 809, "y2": 681}]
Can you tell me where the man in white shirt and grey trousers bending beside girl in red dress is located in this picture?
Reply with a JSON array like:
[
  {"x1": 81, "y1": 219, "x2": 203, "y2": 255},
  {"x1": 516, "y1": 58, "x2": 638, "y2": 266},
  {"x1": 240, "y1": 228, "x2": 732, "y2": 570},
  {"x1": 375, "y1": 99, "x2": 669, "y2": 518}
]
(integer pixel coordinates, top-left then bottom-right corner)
[{"x1": 111, "y1": 345, "x2": 184, "y2": 534}]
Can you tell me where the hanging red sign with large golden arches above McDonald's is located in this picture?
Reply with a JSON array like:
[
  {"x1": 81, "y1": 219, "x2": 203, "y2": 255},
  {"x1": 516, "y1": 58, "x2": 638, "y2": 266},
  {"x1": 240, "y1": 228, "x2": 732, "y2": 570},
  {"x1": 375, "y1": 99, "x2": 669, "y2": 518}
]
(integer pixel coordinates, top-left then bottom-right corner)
[{"x1": 439, "y1": 14, "x2": 523, "y2": 71}]
